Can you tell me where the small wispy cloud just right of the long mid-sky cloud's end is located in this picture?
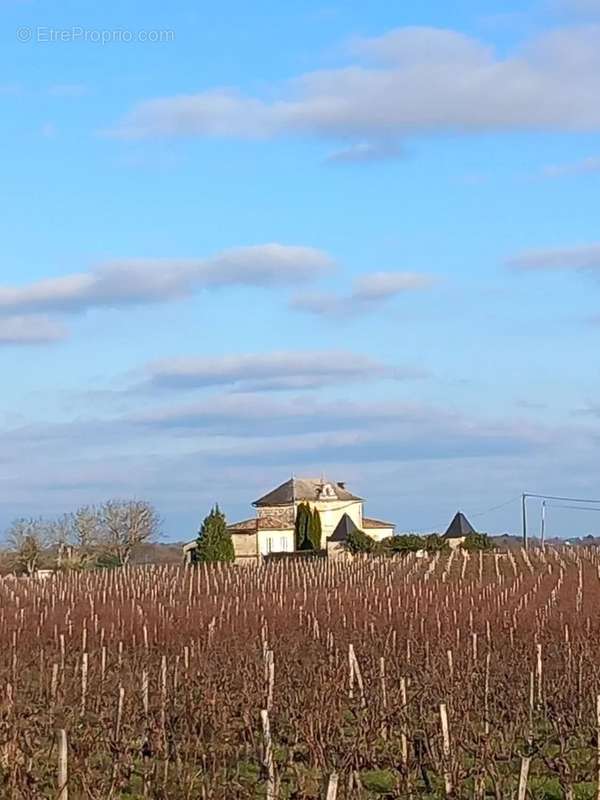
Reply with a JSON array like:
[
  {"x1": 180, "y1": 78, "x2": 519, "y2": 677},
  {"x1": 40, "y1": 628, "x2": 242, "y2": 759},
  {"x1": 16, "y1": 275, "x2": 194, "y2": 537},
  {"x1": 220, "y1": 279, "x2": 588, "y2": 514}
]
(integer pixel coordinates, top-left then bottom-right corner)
[{"x1": 291, "y1": 272, "x2": 437, "y2": 316}]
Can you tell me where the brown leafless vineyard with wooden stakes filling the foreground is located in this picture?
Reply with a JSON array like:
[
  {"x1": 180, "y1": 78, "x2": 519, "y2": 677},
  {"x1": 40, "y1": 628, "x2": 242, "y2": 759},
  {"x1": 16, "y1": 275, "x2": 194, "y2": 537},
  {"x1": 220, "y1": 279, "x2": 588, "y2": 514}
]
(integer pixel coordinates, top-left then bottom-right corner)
[{"x1": 0, "y1": 548, "x2": 600, "y2": 800}]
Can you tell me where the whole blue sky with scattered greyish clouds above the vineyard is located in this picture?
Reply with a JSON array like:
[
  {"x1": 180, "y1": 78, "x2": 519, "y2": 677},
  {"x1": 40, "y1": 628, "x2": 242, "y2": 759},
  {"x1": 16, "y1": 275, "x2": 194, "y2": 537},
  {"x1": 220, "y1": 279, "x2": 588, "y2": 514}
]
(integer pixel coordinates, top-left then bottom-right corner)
[{"x1": 0, "y1": 0, "x2": 600, "y2": 540}]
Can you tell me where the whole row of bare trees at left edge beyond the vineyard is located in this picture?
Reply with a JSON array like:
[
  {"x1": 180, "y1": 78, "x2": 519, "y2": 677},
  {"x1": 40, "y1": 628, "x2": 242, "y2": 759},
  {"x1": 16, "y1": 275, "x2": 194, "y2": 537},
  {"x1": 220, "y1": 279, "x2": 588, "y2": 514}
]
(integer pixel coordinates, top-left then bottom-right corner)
[{"x1": 5, "y1": 500, "x2": 161, "y2": 575}]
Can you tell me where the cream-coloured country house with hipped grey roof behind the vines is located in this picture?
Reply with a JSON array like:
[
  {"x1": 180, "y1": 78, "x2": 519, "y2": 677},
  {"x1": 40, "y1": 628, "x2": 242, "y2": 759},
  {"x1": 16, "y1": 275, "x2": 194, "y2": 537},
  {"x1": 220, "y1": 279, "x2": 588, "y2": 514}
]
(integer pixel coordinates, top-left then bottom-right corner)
[{"x1": 184, "y1": 478, "x2": 394, "y2": 563}]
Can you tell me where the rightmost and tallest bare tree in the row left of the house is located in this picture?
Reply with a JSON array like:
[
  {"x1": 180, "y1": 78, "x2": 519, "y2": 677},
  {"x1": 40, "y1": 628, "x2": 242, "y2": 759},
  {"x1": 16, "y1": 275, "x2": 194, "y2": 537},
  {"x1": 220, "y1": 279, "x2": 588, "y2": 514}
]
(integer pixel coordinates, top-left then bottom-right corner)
[{"x1": 99, "y1": 500, "x2": 160, "y2": 566}]
